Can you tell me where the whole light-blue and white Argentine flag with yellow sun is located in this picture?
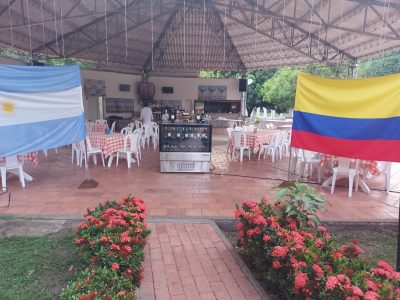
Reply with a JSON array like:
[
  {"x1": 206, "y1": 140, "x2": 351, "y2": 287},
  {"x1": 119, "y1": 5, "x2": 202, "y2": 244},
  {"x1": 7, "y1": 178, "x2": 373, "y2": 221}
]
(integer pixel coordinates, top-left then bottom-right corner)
[{"x1": 0, "y1": 65, "x2": 86, "y2": 157}]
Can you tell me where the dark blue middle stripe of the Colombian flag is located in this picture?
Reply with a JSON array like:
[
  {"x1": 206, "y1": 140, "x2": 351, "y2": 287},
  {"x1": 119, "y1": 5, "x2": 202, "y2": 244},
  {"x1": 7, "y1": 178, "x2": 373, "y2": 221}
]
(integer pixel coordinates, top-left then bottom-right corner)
[{"x1": 293, "y1": 111, "x2": 400, "y2": 140}]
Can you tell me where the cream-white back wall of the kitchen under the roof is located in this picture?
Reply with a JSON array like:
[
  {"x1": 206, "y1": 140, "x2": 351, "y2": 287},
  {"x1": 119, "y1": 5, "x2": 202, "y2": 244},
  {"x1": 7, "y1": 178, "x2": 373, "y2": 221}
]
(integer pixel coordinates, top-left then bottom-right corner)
[{"x1": 82, "y1": 70, "x2": 241, "y2": 115}]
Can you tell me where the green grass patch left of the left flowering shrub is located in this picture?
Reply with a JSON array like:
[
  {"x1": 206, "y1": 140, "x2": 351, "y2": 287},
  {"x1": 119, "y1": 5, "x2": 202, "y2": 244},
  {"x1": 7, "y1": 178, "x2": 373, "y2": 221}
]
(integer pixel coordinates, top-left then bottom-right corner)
[{"x1": 0, "y1": 232, "x2": 79, "y2": 300}]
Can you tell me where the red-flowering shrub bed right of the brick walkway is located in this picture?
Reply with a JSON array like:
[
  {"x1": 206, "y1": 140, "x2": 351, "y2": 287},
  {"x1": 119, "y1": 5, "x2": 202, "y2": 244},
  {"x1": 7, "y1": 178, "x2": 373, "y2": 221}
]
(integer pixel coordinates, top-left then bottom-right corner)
[{"x1": 235, "y1": 182, "x2": 400, "y2": 300}]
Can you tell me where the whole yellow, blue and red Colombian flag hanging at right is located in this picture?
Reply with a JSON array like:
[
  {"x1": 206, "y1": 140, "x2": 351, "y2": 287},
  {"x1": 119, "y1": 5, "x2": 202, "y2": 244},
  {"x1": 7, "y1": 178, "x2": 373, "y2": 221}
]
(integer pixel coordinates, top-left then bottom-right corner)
[{"x1": 292, "y1": 73, "x2": 400, "y2": 162}]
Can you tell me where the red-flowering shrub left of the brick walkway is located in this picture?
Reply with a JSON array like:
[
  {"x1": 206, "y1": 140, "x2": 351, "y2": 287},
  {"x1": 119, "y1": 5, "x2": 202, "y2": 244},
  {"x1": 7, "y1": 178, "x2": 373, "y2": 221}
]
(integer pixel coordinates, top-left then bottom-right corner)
[{"x1": 60, "y1": 195, "x2": 150, "y2": 300}]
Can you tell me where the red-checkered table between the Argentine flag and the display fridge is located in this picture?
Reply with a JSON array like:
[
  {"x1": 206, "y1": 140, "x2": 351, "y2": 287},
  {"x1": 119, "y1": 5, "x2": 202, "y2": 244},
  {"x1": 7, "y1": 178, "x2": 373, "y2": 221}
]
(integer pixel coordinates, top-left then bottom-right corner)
[{"x1": 87, "y1": 132, "x2": 135, "y2": 168}]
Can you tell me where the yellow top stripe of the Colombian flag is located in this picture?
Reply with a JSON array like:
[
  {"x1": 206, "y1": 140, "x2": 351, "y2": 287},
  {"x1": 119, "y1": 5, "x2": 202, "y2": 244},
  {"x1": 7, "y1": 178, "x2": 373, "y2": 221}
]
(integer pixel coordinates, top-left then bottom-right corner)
[{"x1": 294, "y1": 73, "x2": 400, "y2": 119}]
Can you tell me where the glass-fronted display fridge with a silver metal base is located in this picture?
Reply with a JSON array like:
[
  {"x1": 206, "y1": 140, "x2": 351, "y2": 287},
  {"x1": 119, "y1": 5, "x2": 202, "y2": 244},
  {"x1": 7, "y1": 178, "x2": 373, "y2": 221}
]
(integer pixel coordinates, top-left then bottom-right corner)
[{"x1": 159, "y1": 123, "x2": 212, "y2": 173}]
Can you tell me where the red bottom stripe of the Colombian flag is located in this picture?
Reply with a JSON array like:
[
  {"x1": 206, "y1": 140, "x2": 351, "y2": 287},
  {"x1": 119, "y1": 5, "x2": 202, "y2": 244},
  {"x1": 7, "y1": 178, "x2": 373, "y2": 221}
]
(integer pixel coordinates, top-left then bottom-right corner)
[{"x1": 291, "y1": 130, "x2": 400, "y2": 162}]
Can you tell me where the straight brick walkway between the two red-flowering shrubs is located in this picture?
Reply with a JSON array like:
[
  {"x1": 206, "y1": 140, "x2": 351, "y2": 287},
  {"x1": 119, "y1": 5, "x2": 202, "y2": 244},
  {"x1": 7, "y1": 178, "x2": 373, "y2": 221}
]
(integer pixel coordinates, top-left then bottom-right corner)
[{"x1": 140, "y1": 223, "x2": 267, "y2": 300}]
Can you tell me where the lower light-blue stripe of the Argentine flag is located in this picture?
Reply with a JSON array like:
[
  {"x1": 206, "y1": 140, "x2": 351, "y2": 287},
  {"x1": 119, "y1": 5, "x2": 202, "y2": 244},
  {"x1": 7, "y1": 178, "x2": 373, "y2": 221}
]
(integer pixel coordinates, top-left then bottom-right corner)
[{"x1": 0, "y1": 113, "x2": 86, "y2": 157}]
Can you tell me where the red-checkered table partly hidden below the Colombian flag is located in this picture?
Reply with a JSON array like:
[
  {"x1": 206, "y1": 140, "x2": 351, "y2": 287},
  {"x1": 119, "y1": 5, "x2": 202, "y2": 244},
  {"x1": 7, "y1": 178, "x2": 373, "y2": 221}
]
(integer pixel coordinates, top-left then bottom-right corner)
[{"x1": 320, "y1": 154, "x2": 380, "y2": 193}]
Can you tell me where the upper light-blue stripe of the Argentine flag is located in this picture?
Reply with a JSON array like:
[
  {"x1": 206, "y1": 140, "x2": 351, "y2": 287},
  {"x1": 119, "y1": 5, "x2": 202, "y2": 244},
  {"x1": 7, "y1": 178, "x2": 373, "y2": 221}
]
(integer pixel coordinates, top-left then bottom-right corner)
[{"x1": 0, "y1": 65, "x2": 81, "y2": 93}]
